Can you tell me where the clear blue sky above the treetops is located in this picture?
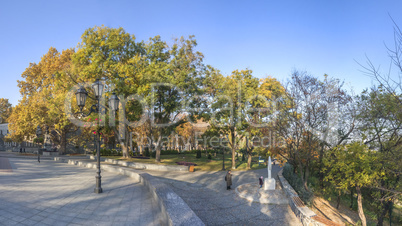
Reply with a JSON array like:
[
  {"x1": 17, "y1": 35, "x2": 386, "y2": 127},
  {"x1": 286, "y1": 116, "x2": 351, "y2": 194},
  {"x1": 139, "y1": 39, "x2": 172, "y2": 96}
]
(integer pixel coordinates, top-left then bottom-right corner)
[{"x1": 0, "y1": 0, "x2": 402, "y2": 105}]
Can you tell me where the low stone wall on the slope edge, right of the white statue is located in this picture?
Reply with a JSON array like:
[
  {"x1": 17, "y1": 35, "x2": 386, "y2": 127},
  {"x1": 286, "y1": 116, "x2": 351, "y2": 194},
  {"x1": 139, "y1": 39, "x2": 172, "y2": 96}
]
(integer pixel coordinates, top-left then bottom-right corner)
[{"x1": 278, "y1": 170, "x2": 326, "y2": 226}]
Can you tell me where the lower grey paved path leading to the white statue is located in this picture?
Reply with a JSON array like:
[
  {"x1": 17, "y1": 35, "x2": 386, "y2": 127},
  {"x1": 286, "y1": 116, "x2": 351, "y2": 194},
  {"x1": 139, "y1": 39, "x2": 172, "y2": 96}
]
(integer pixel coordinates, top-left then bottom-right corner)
[{"x1": 147, "y1": 166, "x2": 301, "y2": 226}]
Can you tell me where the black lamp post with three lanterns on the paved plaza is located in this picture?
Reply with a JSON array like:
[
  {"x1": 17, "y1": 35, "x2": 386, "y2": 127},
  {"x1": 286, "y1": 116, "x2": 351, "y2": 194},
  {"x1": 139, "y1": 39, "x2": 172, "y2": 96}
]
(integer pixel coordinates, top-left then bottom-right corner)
[{"x1": 75, "y1": 79, "x2": 119, "y2": 193}]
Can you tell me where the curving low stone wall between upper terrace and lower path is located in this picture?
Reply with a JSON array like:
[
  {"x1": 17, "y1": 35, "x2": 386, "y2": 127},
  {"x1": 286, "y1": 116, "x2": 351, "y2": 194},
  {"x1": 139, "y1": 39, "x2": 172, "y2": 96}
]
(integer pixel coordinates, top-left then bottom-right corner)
[{"x1": 54, "y1": 157, "x2": 205, "y2": 226}]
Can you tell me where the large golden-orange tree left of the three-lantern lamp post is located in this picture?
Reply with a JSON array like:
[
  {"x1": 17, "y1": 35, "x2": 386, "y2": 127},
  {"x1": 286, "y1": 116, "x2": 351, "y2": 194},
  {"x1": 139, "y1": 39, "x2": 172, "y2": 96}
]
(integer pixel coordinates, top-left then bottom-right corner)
[{"x1": 9, "y1": 48, "x2": 77, "y2": 153}]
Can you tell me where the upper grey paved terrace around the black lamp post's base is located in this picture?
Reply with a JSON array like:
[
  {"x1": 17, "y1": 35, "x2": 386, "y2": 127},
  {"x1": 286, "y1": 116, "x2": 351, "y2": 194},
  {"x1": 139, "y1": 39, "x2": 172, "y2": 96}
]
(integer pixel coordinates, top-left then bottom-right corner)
[{"x1": 0, "y1": 157, "x2": 163, "y2": 226}]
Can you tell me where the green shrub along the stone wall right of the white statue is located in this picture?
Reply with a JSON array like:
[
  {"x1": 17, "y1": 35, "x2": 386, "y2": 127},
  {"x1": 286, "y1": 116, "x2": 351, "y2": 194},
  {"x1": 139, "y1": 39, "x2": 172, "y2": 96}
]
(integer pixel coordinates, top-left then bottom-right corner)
[{"x1": 283, "y1": 163, "x2": 314, "y2": 206}]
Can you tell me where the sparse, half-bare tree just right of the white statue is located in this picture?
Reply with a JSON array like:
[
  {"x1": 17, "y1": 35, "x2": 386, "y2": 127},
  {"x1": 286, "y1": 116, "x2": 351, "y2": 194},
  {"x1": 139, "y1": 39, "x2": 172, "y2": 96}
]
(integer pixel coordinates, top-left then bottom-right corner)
[{"x1": 274, "y1": 71, "x2": 354, "y2": 190}]
